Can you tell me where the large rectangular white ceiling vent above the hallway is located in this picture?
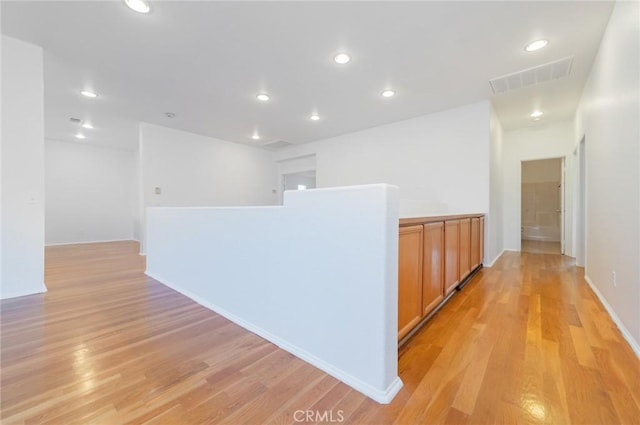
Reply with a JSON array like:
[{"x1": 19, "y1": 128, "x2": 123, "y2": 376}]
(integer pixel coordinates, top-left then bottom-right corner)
[{"x1": 489, "y1": 56, "x2": 573, "y2": 94}]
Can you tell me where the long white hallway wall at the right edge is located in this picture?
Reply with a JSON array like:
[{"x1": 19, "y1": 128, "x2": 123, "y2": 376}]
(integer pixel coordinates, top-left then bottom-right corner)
[{"x1": 574, "y1": 2, "x2": 640, "y2": 357}]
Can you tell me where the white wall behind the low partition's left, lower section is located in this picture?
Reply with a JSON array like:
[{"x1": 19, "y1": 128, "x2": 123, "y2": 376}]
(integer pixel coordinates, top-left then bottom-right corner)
[{"x1": 139, "y1": 123, "x2": 278, "y2": 253}]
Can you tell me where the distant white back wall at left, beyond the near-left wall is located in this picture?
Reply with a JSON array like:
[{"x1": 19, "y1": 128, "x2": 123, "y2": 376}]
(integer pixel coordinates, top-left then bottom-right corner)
[{"x1": 45, "y1": 140, "x2": 137, "y2": 244}]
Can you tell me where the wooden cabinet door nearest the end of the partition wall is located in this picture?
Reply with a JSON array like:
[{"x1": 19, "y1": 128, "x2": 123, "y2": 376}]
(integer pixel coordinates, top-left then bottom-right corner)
[{"x1": 398, "y1": 226, "x2": 423, "y2": 340}]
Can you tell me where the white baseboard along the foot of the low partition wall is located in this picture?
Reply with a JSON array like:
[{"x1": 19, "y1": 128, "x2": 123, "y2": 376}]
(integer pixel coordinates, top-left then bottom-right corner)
[{"x1": 145, "y1": 270, "x2": 402, "y2": 404}]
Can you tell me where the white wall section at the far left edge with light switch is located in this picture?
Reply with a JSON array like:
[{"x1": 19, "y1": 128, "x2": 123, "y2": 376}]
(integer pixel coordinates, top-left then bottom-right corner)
[{"x1": 0, "y1": 36, "x2": 46, "y2": 298}]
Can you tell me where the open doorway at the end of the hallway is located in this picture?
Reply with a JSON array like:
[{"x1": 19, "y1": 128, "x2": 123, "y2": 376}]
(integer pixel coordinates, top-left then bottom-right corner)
[{"x1": 520, "y1": 158, "x2": 564, "y2": 254}]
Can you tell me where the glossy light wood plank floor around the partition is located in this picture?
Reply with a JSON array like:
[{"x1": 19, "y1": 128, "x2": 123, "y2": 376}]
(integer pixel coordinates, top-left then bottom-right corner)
[{"x1": 0, "y1": 242, "x2": 640, "y2": 425}]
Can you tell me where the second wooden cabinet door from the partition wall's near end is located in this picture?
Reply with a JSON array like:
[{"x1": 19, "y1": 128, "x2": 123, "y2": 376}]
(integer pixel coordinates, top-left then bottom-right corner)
[{"x1": 422, "y1": 222, "x2": 444, "y2": 316}]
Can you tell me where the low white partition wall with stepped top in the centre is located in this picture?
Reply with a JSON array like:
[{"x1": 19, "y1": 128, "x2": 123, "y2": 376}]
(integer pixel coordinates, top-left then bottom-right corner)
[{"x1": 147, "y1": 184, "x2": 402, "y2": 403}]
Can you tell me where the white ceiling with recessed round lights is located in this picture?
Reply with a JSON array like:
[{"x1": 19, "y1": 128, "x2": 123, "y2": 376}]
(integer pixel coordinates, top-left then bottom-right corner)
[{"x1": 1, "y1": 1, "x2": 613, "y2": 149}]
